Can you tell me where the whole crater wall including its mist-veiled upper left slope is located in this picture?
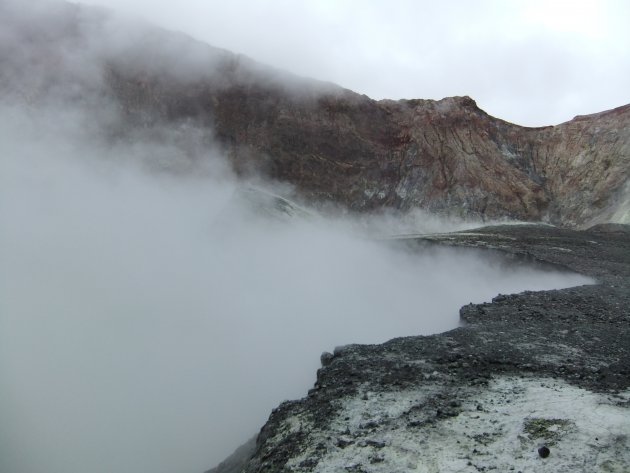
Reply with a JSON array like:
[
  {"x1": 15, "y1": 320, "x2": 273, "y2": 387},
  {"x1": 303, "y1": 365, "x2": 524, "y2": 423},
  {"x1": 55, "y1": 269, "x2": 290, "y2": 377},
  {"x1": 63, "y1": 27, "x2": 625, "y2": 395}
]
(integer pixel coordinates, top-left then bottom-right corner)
[{"x1": 0, "y1": 1, "x2": 630, "y2": 226}]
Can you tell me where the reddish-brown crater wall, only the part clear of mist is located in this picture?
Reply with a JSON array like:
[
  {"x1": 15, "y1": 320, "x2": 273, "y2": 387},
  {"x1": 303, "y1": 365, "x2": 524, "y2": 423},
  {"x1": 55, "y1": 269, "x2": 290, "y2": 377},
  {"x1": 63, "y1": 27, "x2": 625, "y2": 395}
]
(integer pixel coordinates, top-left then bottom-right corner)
[{"x1": 108, "y1": 74, "x2": 630, "y2": 225}]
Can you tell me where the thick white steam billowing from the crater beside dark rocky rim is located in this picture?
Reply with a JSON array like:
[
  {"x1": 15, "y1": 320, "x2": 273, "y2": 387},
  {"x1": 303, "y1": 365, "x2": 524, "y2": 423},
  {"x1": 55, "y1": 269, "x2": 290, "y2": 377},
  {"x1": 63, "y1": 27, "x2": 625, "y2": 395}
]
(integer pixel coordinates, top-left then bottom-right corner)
[{"x1": 0, "y1": 2, "x2": 592, "y2": 473}]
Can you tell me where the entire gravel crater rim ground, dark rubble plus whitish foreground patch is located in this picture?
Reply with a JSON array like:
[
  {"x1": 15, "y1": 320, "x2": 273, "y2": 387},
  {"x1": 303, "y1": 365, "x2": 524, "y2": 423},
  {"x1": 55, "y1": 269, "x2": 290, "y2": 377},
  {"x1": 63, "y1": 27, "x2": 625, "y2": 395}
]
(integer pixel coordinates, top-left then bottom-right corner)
[{"x1": 211, "y1": 225, "x2": 630, "y2": 473}]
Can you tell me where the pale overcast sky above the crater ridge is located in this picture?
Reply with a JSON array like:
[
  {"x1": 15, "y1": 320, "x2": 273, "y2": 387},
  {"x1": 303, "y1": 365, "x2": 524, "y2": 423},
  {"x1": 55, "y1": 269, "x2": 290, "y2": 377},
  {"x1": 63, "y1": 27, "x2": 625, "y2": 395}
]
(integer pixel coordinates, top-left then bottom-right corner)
[{"x1": 75, "y1": 0, "x2": 630, "y2": 126}]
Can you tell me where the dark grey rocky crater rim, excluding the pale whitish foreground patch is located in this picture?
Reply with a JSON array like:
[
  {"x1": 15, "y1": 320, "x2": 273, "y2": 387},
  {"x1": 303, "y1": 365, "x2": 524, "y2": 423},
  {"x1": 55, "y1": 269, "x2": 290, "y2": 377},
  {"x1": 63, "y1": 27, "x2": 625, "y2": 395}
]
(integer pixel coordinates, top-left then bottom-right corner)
[{"x1": 214, "y1": 225, "x2": 630, "y2": 473}]
